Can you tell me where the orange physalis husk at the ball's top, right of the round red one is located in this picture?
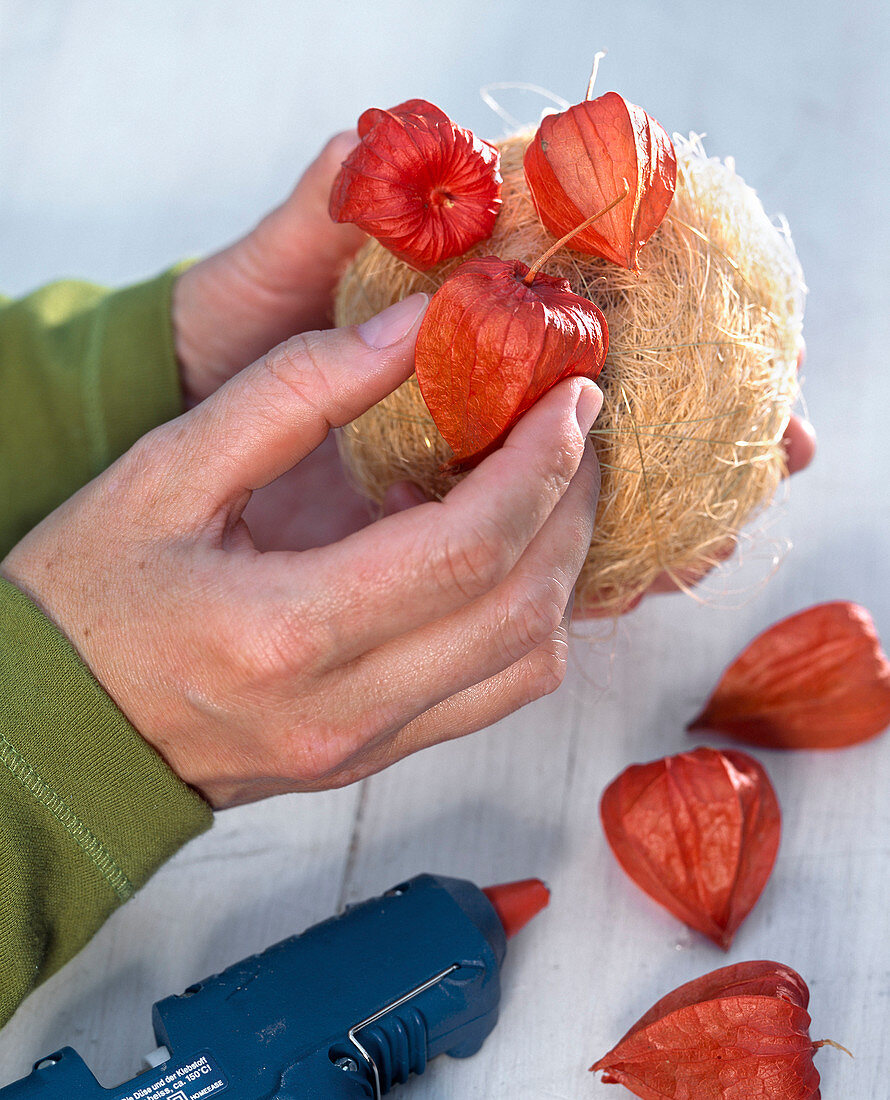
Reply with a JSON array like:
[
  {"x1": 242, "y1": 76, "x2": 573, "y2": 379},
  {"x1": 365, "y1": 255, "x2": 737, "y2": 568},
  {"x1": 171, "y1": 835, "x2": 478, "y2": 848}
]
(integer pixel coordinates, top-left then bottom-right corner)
[{"x1": 525, "y1": 91, "x2": 677, "y2": 271}]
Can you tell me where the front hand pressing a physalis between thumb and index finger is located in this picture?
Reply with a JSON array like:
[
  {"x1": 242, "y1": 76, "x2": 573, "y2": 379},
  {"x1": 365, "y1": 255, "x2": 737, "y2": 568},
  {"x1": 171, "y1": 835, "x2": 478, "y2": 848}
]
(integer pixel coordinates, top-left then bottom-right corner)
[{"x1": 1, "y1": 296, "x2": 602, "y2": 806}]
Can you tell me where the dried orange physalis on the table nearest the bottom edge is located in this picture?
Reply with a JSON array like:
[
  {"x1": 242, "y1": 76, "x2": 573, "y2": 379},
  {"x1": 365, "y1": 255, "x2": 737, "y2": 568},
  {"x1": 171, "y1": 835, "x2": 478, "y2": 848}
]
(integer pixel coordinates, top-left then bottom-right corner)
[{"x1": 591, "y1": 961, "x2": 849, "y2": 1100}]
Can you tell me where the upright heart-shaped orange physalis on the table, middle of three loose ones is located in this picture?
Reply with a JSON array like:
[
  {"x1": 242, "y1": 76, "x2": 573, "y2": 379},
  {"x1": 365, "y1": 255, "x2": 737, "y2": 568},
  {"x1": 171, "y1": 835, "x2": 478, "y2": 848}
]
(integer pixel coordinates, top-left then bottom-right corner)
[{"x1": 600, "y1": 748, "x2": 781, "y2": 948}]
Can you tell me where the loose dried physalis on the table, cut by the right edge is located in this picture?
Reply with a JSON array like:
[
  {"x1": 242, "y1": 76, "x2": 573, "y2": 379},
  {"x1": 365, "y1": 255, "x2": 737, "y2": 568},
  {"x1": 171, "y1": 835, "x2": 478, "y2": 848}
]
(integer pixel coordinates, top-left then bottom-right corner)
[{"x1": 689, "y1": 601, "x2": 890, "y2": 749}]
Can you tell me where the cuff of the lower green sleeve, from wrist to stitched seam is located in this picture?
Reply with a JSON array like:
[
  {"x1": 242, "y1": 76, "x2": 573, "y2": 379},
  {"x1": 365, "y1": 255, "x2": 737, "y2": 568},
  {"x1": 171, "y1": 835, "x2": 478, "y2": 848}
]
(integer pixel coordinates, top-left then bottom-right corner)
[{"x1": 0, "y1": 581, "x2": 212, "y2": 901}]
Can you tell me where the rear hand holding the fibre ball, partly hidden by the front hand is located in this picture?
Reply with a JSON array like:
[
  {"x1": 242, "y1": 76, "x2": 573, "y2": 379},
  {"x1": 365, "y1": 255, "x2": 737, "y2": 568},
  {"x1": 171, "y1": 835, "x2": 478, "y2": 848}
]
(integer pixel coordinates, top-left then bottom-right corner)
[{"x1": 173, "y1": 131, "x2": 391, "y2": 550}]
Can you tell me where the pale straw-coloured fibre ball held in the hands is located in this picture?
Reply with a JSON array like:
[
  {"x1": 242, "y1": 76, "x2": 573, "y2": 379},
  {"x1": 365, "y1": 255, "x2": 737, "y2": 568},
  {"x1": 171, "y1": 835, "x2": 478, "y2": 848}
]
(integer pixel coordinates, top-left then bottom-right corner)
[{"x1": 337, "y1": 134, "x2": 804, "y2": 614}]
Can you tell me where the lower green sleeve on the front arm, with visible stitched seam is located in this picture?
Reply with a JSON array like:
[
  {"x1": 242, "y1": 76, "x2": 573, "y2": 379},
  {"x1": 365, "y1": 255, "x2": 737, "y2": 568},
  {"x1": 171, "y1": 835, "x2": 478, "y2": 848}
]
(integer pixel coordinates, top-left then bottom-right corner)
[{"x1": 0, "y1": 580, "x2": 211, "y2": 1025}]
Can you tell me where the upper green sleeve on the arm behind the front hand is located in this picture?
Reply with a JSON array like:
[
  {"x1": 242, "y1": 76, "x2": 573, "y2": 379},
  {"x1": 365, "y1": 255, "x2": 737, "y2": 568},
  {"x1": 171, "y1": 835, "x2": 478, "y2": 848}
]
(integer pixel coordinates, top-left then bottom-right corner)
[{"x1": 0, "y1": 267, "x2": 191, "y2": 558}]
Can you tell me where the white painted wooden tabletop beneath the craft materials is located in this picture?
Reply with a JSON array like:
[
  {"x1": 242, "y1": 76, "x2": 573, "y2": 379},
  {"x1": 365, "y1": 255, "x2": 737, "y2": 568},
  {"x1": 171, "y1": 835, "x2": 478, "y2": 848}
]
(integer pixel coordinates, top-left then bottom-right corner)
[{"x1": 0, "y1": 0, "x2": 890, "y2": 1100}]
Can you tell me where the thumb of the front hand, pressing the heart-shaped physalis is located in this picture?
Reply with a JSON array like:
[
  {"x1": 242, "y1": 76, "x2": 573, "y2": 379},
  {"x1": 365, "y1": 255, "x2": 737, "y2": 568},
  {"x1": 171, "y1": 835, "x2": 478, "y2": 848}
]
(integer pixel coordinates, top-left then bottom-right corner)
[{"x1": 182, "y1": 294, "x2": 429, "y2": 499}]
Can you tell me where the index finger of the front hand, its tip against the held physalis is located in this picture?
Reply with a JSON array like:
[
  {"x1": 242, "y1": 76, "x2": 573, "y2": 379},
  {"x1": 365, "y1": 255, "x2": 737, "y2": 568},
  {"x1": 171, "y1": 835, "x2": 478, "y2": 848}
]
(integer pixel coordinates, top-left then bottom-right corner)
[{"x1": 283, "y1": 378, "x2": 602, "y2": 663}]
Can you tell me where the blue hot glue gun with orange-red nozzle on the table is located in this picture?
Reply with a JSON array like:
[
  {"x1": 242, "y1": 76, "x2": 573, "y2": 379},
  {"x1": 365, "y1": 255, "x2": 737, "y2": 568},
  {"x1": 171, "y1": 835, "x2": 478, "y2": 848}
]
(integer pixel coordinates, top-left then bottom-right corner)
[{"x1": 0, "y1": 875, "x2": 550, "y2": 1100}]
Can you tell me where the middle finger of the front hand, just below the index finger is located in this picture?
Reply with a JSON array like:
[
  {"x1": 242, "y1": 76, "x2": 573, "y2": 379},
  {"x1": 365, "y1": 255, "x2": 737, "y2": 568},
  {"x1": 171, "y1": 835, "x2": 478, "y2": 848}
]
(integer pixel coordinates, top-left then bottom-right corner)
[{"x1": 316, "y1": 437, "x2": 600, "y2": 728}]
